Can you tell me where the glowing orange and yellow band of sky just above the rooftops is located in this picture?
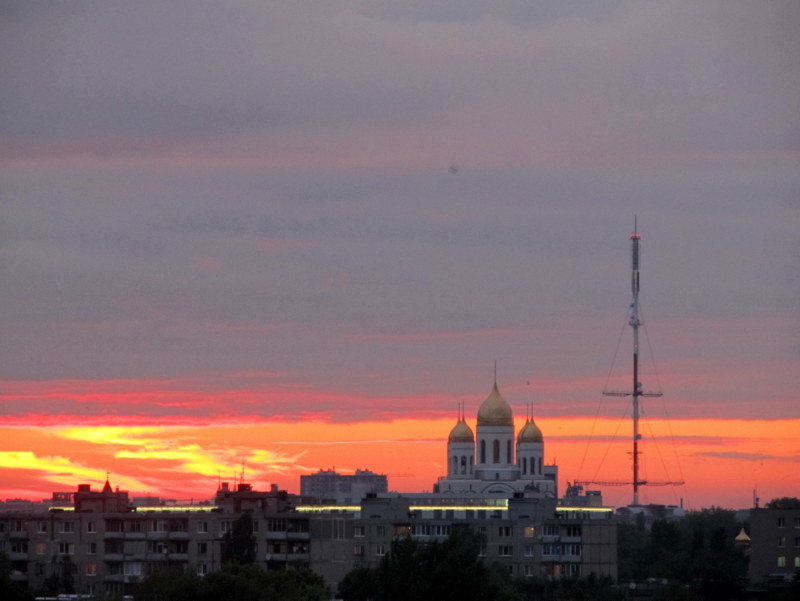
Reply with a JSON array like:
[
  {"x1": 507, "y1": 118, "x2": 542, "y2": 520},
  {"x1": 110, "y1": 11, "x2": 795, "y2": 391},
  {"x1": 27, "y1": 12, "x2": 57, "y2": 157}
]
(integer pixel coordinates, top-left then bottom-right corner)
[{"x1": 0, "y1": 417, "x2": 800, "y2": 507}]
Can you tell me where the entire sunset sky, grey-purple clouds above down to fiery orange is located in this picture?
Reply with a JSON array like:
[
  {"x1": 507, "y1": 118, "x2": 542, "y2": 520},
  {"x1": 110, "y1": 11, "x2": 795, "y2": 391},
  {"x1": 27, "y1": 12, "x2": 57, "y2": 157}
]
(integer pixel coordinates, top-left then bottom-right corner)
[{"x1": 0, "y1": 0, "x2": 800, "y2": 508}]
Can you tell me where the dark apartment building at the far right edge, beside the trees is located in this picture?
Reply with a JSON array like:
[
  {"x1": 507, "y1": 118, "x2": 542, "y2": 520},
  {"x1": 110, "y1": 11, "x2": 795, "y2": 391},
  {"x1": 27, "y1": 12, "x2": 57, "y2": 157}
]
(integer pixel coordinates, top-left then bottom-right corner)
[{"x1": 749, "y1": 508, "x2": 800, "y2": 584}]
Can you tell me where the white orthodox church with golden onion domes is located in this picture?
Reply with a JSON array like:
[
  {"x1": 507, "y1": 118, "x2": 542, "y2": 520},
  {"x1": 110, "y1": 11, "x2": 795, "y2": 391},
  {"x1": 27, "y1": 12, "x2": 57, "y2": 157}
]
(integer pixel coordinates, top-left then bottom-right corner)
[{"x1": 434, "y1": 382, "x2": 558, "y2": 497}]
